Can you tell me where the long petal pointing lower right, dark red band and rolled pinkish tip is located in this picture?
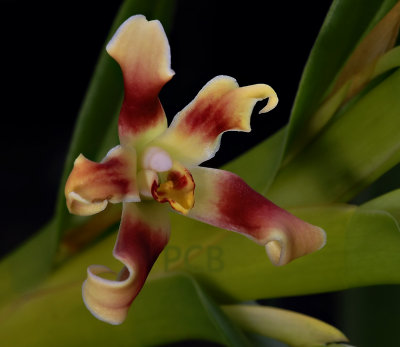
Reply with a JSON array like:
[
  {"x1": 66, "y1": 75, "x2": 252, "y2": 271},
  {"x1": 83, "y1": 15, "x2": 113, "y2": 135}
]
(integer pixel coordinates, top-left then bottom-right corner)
[{"x1": 188, "y1": 167, "x2": 326, "y2": 265}]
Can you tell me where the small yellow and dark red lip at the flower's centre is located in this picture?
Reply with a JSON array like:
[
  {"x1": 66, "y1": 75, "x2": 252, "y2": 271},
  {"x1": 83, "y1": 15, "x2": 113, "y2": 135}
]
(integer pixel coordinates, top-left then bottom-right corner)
[{"x1": 151, "y1": 161, "x2": 195, "y2": 214}]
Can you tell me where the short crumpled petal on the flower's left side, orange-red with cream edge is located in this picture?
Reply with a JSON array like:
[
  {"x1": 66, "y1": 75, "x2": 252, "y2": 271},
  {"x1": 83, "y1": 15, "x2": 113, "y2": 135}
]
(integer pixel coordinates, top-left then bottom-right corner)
[{"x1": 65, "y1": 146, "x2": 140, "y2": 216}]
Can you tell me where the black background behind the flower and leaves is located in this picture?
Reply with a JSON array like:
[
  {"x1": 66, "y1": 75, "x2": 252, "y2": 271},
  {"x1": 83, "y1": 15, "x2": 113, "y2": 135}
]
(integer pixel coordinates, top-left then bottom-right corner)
[{"x1": 0, "y1": 0, "x2": 395, "y2": 347}]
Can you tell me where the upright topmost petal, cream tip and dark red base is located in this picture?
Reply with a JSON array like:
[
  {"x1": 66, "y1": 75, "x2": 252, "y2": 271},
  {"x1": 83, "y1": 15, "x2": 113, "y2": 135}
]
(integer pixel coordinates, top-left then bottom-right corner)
[{"x1": 107, "y1": 15, "x2": 174, "y2": 147}]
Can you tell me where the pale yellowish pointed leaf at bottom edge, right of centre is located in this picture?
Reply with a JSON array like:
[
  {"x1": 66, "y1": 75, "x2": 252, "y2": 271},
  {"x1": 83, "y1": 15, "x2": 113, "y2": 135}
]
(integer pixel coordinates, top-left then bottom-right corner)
[{"x1": 222, "y1": 305, "x2": 348, "y2": 347}]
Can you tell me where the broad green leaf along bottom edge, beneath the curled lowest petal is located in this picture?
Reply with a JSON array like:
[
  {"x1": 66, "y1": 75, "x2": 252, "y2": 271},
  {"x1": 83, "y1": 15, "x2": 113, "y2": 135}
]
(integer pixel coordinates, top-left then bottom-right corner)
[{"x1": 0, "y1": 274, "x2": 248, "y2": 347}]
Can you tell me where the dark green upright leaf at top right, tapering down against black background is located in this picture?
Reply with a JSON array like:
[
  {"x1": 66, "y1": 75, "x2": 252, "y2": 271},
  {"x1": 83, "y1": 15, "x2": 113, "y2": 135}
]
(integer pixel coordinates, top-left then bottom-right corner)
[{"x1": 285, "y1": 0, "x2": 397, "y2": 160}]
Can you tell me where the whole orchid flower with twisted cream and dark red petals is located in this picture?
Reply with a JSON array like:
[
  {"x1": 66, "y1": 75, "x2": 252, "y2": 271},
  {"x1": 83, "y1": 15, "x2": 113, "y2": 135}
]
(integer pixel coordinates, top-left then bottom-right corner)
[{"x1": 65, "y1": 15, "x2": 325, "y2": 324}]
